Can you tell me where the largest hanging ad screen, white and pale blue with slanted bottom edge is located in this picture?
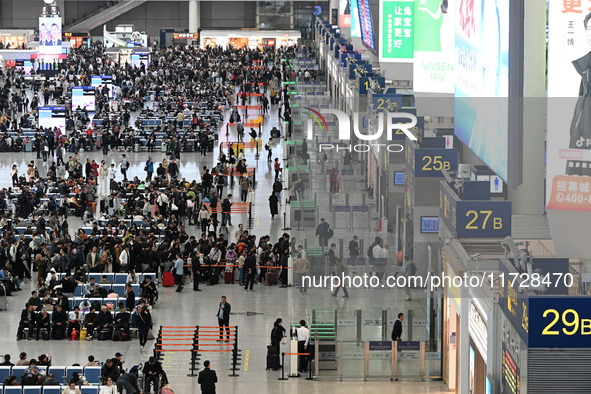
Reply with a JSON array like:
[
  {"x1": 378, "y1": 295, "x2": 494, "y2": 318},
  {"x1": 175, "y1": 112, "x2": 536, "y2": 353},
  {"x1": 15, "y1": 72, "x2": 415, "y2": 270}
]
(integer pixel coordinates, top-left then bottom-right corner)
[{"x1": 454, "y1": 0, "x2": 510, "y2": 181}]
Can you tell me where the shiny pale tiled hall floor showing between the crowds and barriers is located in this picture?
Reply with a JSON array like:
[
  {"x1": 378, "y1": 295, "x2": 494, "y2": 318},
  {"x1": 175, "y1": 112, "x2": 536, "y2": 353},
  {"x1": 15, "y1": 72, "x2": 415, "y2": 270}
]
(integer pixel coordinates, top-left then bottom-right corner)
[{"x1": 0, "y1": 81, "x2": 445, "y2": 394}]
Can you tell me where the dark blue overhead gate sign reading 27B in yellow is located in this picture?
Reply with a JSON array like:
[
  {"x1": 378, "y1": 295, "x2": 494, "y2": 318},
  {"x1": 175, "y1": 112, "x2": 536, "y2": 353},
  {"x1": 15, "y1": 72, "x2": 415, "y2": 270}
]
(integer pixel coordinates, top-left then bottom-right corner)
[{"x1": 439, "y1": 182, "x2": 512, "y2": 239}]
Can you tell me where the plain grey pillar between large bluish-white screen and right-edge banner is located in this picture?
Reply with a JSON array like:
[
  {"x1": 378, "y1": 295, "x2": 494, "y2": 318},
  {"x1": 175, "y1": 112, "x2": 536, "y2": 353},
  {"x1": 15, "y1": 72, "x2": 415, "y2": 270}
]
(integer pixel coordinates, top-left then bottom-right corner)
[{"x1": 508, "y1": 0, "x2": 546, "y2": 215}]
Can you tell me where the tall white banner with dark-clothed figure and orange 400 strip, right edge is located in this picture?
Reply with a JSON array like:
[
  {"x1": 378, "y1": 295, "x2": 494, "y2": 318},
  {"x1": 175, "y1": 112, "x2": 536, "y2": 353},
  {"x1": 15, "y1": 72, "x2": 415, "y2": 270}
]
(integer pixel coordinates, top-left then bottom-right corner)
[{"x1": 546, "y1": 0, "x2": 591, "y2": 212}]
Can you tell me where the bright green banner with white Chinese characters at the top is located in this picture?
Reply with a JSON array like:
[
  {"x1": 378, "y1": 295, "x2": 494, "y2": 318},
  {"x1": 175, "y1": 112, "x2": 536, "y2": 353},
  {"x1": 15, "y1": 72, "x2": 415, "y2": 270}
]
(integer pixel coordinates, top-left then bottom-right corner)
[{"x1": 380, "y1": 0, "x2": 422, "y2": 63}]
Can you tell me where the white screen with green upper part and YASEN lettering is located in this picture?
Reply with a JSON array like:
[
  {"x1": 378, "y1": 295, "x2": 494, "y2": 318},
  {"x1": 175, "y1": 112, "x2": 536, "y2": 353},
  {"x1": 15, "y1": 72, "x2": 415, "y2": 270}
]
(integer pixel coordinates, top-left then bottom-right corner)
[{"x1": 413, "y1": 0, "x2": 459, "y2": 94}]
